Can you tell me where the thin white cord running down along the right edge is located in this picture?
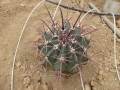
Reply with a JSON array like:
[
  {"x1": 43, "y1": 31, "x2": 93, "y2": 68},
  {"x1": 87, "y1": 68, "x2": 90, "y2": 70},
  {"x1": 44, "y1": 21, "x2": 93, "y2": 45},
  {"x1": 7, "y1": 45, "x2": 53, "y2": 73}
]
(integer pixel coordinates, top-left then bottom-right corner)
[{"x1": 111, "y1": 12, "x2": 120, "y2": 82}]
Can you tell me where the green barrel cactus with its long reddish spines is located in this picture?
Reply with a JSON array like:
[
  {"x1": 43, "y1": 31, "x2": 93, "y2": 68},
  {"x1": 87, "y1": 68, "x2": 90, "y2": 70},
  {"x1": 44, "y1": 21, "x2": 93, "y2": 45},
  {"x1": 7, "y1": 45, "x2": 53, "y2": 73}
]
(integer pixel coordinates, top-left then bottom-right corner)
[{"x1": 27, "y1": 6, "x2": 98, "y2": 83}]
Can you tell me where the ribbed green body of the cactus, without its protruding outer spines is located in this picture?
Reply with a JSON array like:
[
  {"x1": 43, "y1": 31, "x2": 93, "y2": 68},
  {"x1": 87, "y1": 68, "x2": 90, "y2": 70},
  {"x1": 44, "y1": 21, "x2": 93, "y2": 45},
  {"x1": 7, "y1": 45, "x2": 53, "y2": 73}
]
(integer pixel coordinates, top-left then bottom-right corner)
[{"x1": 38, "y1": 21, "x2": 89, "y2": 73}]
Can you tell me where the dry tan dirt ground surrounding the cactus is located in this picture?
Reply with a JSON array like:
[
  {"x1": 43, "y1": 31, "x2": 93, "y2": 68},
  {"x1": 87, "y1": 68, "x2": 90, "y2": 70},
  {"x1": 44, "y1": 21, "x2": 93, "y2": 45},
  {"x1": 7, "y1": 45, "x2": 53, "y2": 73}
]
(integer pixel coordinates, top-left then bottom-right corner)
[{"x1": 0, "y1": 0, "x2": 120, "y2": 90}]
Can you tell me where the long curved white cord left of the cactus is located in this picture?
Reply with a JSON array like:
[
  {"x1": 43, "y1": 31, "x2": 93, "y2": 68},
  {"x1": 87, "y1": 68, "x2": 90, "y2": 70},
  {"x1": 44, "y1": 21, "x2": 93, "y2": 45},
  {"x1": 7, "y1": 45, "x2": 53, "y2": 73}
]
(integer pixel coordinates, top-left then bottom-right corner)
[{"x1": 11, "y1": 0, "x2": 45, "y2": 90}]
